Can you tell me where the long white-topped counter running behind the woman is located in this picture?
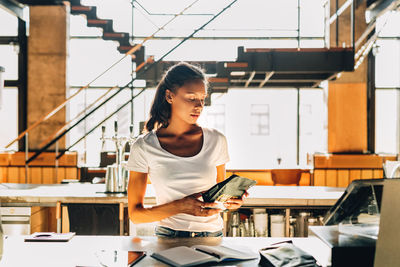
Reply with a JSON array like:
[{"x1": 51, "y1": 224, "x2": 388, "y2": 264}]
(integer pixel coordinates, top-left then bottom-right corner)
[{"x1": 0, "y1": 183, "x2": 344, "y2": 207}]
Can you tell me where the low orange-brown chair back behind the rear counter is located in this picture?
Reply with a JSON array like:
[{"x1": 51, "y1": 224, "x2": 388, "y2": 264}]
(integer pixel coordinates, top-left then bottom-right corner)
[{"x1": 271, "y1": 169, "x2": 310, "y2": 186}]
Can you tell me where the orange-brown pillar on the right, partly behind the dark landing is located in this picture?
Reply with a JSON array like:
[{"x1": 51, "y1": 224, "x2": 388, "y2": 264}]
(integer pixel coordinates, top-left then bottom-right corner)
[{"x1": 328, "y1": 0, "x2": 368, "y2": 153}]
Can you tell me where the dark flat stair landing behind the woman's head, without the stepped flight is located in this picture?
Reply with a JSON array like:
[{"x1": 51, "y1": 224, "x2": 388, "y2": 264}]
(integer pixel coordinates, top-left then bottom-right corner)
[{"x1": 138, "y1": 47, "x2": 354, "y2": 92}]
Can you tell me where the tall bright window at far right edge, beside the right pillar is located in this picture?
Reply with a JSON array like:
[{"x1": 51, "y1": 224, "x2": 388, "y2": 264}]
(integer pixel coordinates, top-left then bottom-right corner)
[{"x1": 374, "y1": 11, "x2": 400, "y2": 154}]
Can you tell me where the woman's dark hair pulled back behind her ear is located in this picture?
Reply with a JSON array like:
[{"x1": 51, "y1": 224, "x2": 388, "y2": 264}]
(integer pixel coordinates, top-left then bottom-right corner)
[{"x1": 144, "y1": 62, "x2": 207, "y2": 132}]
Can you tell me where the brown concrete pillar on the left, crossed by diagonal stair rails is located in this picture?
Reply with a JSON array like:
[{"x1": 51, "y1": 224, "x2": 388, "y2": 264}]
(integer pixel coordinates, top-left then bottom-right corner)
[{"x1": 28, "y1": 6, "x2": 69, "y2": 150}]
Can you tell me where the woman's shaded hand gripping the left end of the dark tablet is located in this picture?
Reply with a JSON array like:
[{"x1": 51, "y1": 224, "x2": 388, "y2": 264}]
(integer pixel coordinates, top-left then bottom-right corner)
[{"x1": 177, "y1": 193, "x2": 222, "y2": 217}]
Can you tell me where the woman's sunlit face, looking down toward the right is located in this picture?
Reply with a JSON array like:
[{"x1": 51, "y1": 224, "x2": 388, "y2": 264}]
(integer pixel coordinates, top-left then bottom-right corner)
[{"x1": 166, "y1": 80, "x2": 207, "y2": 124}]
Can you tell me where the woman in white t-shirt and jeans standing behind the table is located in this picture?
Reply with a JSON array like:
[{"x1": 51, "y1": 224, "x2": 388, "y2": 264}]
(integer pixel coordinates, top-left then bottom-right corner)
[{"x1": 127, "y1": 63, "x2": 242, "y2": 237}]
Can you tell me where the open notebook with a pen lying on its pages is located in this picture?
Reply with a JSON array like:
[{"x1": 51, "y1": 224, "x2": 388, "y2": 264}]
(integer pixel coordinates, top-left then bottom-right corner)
[{"x1": 151, "y1": 245, "x2": 258, "y2": 267}]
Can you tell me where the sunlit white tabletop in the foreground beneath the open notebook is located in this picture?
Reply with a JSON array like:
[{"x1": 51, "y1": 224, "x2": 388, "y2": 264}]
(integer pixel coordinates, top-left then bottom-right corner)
[{"x1": 0, "y1": 236, "x2": 330, "y2": 267}]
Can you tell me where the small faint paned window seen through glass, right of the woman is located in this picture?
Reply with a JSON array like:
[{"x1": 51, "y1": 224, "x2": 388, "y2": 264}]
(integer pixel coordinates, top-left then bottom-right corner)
[{"x1": 250, "y1": 104, "x2": 269, "y2": 135}]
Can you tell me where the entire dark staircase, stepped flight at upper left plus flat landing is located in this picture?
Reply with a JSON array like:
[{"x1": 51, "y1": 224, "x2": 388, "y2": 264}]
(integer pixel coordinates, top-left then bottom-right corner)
[{"x1": 7, "y1": 0, "x2": 354, "y2": 93}]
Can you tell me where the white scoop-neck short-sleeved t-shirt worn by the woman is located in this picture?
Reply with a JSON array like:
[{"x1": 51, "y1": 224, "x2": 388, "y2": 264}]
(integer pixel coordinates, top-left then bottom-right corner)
[{"x1": 127, "y1": 127, "x2": 229, "y2": 232}]
